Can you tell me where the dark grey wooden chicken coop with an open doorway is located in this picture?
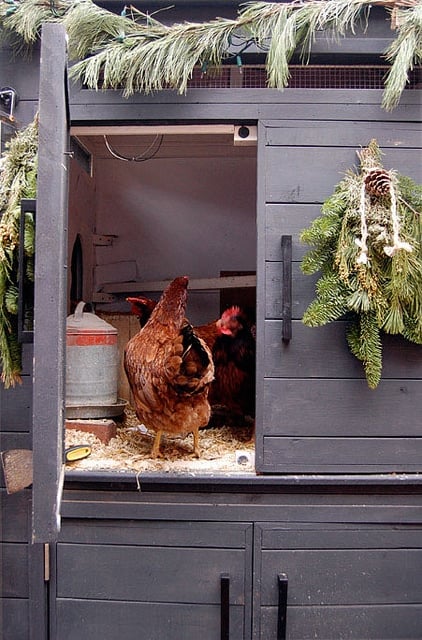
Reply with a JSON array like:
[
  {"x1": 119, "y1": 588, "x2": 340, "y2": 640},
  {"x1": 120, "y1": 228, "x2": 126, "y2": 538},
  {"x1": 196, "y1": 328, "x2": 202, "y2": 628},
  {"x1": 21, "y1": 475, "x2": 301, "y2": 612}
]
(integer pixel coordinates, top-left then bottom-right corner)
[{"x1": 0, "y1": 0, "x2": 422, "y2": 640}]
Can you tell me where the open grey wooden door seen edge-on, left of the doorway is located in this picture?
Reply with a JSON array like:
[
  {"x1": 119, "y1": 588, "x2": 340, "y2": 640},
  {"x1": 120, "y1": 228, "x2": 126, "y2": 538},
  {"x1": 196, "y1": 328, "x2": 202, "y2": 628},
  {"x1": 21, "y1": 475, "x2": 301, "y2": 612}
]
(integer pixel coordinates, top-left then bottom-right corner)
[{"x1": 32, "y1": 24, "x2": 69, "y2": 543}]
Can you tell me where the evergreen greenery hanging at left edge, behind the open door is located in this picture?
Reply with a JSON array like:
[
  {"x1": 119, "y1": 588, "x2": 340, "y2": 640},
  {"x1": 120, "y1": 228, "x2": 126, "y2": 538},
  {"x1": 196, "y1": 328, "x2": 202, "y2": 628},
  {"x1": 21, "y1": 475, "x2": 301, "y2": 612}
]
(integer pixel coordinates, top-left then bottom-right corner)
[{"x1": 0, "y1": 118, "x2": 38, "y2": 388}]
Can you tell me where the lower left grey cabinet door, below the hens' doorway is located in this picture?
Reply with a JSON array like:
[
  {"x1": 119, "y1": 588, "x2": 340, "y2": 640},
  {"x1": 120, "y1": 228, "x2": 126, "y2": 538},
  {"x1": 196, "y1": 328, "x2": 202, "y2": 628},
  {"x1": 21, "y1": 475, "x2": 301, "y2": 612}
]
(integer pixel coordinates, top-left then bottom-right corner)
[{"x1": 57, "y1": 521, "x2": 251, "y2": 640}]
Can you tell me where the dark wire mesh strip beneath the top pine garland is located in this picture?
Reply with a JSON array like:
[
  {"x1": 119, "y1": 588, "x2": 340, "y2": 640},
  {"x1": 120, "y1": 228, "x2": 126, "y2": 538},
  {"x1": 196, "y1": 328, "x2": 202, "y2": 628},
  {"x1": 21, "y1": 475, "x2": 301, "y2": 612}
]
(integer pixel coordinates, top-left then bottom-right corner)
[{"x1": 188, "y1": 65, "x2": 422, "y2": 89}]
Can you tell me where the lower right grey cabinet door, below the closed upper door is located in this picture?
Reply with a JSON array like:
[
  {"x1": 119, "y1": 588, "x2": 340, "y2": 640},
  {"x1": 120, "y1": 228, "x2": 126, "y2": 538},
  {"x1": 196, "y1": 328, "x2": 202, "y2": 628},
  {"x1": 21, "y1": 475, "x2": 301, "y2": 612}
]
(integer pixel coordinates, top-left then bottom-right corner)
[{"x1": 254, "y1": 523, "x2": 422, "y2": 640}]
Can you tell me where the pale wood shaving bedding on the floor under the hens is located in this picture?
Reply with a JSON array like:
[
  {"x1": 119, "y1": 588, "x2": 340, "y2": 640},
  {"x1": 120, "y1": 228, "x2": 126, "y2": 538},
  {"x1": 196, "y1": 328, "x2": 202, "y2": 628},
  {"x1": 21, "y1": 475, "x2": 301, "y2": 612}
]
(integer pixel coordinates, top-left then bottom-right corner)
[{"x1": 66, "y1": 407, "x2": 254, "y2": 474}]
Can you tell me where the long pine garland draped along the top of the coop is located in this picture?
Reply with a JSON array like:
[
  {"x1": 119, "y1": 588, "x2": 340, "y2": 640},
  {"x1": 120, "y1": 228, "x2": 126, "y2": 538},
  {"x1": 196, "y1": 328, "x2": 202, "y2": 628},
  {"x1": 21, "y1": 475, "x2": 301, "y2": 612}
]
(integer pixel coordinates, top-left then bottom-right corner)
[{"x1": 0, "y1": 0, "x2": 422, "y2": 110}]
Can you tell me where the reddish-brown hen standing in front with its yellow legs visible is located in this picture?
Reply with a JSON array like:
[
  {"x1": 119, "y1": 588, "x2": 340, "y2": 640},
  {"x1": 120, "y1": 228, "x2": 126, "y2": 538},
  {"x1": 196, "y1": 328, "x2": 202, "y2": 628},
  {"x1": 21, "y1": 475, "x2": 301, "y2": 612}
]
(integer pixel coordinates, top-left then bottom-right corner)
[{"x1": 124, "y1": 276, "x2": 214, "y2": 458}]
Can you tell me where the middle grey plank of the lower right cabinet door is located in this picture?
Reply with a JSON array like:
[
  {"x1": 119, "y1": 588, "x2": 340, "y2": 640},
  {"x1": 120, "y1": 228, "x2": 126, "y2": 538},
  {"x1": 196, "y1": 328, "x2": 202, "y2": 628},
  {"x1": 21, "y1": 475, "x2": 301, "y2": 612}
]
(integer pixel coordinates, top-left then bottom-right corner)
[{"x1": 261, "y1": 552, "x2": 422, "y2": 604}]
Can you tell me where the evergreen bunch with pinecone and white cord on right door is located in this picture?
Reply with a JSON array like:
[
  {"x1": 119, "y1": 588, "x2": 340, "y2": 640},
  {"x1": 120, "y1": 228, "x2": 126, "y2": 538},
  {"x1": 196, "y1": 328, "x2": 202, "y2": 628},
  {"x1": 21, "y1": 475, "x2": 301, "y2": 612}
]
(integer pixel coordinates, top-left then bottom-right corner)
[{"x1": 300, "y1": 140, "x2": 422, "y2": 389}]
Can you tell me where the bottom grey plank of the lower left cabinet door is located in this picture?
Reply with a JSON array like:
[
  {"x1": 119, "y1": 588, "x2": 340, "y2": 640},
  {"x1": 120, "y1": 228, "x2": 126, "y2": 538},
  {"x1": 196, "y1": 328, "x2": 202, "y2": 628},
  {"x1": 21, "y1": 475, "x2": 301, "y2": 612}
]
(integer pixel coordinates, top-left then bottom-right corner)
[{"x1": 57, "y1": 600, "x2": 246, "y2": 640}]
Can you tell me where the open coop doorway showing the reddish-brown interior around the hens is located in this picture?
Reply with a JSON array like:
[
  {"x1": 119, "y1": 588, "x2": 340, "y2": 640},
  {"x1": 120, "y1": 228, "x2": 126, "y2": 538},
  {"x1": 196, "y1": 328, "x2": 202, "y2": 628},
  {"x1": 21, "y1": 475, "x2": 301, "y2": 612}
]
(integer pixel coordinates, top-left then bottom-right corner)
[{"x1": 67, "y1": 123, "x2": 257, "y2": 472}]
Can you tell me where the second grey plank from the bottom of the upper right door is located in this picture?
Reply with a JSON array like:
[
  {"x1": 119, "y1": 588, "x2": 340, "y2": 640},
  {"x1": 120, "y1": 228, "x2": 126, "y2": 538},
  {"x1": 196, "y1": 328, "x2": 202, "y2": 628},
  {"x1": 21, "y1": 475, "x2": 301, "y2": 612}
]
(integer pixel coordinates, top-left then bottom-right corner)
[{"x1": 263, "y1": 378, "x2": 422, "y2": 438}]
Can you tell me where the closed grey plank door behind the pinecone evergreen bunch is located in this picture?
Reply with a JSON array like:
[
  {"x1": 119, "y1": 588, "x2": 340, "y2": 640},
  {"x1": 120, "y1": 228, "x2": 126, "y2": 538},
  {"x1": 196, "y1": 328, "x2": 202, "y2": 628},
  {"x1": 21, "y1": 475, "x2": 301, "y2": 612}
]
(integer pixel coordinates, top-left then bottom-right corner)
[{"x1": 256, "y1": 120, "x2": 422, "y2": 473}]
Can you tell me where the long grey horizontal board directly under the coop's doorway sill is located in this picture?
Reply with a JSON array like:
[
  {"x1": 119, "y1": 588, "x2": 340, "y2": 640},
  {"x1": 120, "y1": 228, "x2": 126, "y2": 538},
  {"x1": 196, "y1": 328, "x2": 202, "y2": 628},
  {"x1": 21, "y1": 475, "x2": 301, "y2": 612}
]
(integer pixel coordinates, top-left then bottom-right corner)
[{"x1": 63, "y1": 488, "x2": 422, "y2": 508}]
